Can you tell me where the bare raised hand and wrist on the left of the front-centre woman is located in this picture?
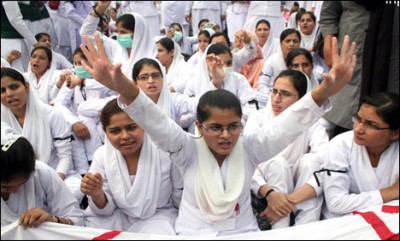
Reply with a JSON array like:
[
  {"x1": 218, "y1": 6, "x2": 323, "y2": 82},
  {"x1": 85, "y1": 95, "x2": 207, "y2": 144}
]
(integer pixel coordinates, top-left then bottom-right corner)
[{"x1": 80, "y1": 35, "x2": 139, "y2": 105}]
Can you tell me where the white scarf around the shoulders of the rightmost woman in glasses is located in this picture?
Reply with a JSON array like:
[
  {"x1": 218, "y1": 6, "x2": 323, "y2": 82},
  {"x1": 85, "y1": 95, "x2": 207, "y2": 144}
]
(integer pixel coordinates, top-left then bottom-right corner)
[{"x1": 350, "y1": 141, "x2": 399, "y2": 192}]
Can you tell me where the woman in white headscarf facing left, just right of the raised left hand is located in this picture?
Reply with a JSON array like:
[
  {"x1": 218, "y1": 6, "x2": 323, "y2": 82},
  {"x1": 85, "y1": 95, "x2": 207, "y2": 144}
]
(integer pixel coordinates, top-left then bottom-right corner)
[{"x1": 156, "y1": 37, "x2": 191, "y2": 93}]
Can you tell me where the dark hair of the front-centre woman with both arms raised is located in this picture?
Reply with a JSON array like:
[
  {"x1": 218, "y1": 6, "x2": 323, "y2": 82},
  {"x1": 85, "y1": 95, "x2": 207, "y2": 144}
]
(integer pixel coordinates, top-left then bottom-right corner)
[{"x1": 197, "y1": 89, "x2": 243, "y2": 123}]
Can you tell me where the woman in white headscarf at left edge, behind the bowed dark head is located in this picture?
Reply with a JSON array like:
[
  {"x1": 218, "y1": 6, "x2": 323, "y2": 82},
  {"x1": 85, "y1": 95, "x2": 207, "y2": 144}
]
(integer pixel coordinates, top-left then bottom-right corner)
[{"x1": 1, "y1": 67, "x2": 84, "y2": 202}]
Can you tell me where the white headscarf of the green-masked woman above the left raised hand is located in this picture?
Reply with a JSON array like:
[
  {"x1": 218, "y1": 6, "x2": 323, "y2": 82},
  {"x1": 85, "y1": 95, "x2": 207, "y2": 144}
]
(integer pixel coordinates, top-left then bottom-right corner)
[{"x1": 114, "y1": 12, "x2": 157, "y2": 77}]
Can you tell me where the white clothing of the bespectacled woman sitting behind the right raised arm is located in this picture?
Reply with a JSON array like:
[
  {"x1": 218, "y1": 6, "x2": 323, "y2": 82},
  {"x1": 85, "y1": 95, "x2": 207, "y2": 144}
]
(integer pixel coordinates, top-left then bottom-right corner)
[{"x1": 250, "y1": 103, "x2": 329, "y2": 229}]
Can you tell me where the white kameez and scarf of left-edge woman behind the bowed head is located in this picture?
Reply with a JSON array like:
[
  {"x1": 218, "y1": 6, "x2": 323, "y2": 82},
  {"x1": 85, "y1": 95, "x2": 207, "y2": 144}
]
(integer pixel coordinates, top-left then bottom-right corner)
[{"x1": 1, "y1": 70, "x2": 83, "y2": 202}]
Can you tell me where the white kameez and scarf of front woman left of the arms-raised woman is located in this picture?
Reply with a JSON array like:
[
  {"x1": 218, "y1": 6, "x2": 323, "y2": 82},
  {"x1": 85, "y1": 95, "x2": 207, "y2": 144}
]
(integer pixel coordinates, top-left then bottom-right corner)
[{"x1": 85, "y1": 137, "x2": 178, "y2": 235}]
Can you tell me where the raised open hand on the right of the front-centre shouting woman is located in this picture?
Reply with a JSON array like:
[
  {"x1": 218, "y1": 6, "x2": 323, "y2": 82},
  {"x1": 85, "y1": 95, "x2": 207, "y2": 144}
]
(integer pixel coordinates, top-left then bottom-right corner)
[{"x1": 312, "y1": 35, "x2": 357, "y2": 106}]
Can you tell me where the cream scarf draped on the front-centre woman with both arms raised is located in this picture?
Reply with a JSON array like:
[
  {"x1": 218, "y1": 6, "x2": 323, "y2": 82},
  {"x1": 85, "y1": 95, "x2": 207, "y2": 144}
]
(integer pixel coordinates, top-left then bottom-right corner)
[{"x1": 195, "y1": 134, "x2": 245, "y2": 222}]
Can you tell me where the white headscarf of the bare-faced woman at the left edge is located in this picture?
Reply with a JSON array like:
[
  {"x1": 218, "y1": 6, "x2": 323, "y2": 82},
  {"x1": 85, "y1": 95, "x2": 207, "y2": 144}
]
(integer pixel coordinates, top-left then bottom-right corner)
[{"x1": 1, "y1": 68, "x2": 53, "y2": 163}]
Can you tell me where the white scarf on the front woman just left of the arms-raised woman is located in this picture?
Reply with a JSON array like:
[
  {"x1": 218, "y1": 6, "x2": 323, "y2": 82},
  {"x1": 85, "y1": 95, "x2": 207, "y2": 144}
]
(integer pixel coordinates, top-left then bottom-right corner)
[{"x1": 104, "y1": 134, "x2": 161, "y2": 219}]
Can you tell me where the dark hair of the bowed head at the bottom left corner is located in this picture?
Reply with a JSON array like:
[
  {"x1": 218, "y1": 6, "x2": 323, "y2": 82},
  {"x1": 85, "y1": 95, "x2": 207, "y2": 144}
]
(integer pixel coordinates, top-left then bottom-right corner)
[{"x1": 1, "y1": 137, "x2": 36, "y2": 183}]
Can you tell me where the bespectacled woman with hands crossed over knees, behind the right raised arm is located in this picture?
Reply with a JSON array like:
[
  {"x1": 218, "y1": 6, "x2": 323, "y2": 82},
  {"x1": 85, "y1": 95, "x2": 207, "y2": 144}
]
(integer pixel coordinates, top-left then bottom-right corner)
[{"x1": 250, "y1": 70, "x2": 329, "y2": 229}]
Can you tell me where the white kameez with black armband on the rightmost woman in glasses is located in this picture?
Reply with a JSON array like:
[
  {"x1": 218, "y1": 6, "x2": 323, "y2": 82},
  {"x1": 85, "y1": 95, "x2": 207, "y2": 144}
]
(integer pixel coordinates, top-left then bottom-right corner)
[{"x1": 319, "y1": 131, "x2": 399, "y2": 218}]
